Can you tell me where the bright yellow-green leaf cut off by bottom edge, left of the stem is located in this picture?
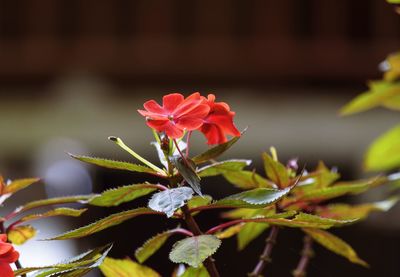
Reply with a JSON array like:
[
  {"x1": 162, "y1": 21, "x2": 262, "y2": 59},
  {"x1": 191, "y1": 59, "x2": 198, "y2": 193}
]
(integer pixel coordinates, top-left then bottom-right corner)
[{"x1": 100, "y1": 258, "x2": 161, "y2": 277}]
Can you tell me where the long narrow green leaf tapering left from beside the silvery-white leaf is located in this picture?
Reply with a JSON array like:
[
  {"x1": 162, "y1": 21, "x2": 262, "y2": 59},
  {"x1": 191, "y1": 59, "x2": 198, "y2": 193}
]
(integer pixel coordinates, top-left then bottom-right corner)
[{"x1": 46, "y1": 208, "x2": 158, "y2": 240}]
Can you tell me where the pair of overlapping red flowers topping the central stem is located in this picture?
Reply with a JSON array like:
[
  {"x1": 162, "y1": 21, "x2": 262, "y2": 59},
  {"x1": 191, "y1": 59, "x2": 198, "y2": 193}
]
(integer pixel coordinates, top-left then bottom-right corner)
[{"x1": 138, "y1": 92, "x2": 240, "y2": 144}]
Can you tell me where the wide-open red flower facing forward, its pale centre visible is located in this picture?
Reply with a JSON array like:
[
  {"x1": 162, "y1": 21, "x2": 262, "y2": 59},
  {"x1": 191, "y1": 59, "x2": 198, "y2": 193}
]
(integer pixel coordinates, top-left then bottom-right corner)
[{"x1": 138, "y1": 92, "x2": 210, "y2": 138}]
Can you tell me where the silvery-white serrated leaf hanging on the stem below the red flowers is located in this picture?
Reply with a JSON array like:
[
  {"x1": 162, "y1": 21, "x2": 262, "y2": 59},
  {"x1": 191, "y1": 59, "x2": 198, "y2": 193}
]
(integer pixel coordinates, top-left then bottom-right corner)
[{"x1": 148, "y1": 187, "x2": 194, "y2": 217}]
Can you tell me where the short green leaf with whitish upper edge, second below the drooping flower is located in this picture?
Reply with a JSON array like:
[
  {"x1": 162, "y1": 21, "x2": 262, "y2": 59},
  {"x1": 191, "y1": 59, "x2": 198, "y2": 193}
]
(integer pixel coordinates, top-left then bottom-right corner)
[{"x1": 197, "y1": 160, "x2": 251, "y2": 177}]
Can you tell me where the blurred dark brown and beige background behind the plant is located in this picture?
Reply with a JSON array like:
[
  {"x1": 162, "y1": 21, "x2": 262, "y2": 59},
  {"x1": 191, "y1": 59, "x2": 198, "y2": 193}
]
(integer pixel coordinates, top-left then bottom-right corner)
[{"x1": 0, "y1": 0, "x2": 400, "y2": 276}]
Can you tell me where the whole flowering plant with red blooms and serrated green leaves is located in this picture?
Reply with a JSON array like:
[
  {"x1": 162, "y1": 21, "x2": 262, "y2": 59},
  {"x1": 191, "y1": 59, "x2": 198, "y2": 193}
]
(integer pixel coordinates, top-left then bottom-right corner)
[{"x1": 0, "y1": 93, "x2": 388, "y2": 277}]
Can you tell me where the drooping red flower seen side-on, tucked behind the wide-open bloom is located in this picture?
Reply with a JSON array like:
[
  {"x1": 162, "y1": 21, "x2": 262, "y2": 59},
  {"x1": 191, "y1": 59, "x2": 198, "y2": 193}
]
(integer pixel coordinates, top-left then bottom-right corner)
[{"x1": 200, "y1": 94, "x2": 240, "y2": 144}]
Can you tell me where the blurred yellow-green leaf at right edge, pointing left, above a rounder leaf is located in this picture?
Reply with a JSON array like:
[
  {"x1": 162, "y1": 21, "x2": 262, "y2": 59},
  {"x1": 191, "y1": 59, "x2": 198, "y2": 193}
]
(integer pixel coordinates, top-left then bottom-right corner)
[{"x1": 340, "y1": 81, "x2": 400, "y2": 115}]
